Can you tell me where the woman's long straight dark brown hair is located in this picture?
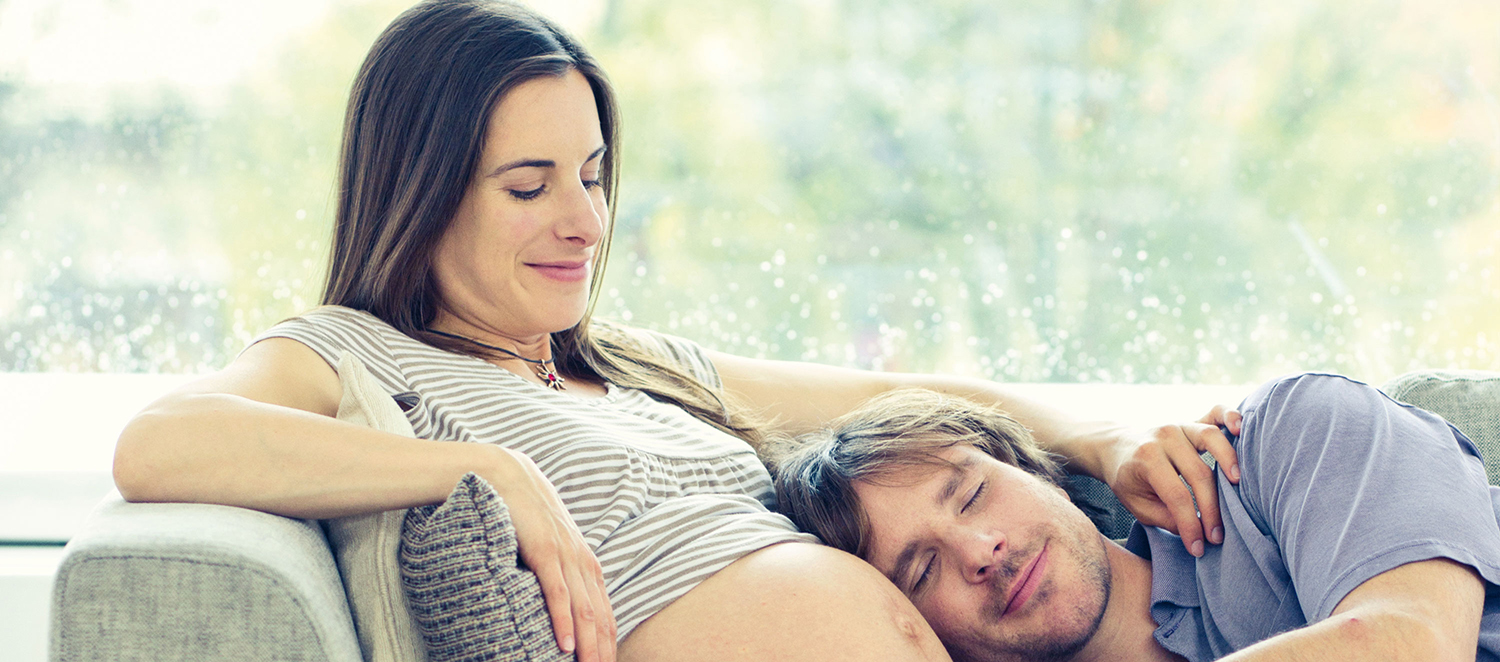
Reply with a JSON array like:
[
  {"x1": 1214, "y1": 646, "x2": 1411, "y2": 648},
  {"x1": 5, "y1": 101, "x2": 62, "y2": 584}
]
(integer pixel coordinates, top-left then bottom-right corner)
[{"x1": 323, "y1": 0, "x2": 759, "y2": 443}]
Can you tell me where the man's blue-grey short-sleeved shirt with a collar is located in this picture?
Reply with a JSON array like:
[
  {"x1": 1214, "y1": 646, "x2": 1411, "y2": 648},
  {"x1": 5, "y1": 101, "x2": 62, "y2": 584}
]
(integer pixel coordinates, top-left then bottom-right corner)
[{"x1": 1125, "y1": 374, "x2": 1500, "y2": 662}]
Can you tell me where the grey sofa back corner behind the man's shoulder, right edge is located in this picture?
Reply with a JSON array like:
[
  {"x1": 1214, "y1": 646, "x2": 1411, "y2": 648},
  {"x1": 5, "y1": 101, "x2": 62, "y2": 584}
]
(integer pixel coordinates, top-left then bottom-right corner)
[{"x1": 1382, "y1": 371, "x2": 1500, "y2": 485}]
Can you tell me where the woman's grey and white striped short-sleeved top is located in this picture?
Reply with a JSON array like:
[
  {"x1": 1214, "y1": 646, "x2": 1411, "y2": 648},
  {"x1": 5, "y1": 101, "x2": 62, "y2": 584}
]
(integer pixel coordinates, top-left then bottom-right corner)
[{"x1": 261, "y1": 306, "x2": 818, "y2": 641}]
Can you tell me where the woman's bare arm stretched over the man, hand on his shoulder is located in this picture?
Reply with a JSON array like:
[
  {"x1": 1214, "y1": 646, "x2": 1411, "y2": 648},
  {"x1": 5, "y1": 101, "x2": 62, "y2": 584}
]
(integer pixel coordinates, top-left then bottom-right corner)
[{"x1": 710, "y1": 351, "x2": 1239, "y2": 555}]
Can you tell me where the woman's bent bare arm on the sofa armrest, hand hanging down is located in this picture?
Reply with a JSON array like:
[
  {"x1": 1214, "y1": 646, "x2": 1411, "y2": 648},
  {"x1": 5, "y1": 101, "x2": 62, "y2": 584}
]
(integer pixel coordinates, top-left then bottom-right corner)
[{"x1": 114, "y1": 338, "x2": 617, "y2": 662}]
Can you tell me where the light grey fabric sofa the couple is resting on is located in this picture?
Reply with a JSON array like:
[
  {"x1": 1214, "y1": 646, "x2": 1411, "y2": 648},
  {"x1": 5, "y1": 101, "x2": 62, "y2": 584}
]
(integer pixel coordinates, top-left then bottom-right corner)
[{"x1": 51, "y1": 371, "x2": 1500, "y2": 662}]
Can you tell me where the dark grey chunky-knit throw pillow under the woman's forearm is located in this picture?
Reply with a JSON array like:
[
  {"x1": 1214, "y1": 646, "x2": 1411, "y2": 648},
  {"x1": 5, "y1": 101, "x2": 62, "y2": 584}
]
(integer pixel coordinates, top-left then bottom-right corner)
[{"x1": 401, "y1": 473, "x2": 575, "y2": 662}]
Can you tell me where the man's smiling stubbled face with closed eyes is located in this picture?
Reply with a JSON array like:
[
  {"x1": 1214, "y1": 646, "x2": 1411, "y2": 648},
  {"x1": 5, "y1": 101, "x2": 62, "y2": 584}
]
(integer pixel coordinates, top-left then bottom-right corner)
[{"x1": 855, "y1": 444, "x2": 1110, "y2": 660}]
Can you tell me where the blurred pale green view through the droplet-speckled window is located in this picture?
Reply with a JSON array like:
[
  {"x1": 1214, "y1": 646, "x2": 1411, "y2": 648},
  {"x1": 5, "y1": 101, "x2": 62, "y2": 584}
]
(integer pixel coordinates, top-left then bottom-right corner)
[{"x1": 0, "y1": 0, "x2": 1500, "y2": 384}]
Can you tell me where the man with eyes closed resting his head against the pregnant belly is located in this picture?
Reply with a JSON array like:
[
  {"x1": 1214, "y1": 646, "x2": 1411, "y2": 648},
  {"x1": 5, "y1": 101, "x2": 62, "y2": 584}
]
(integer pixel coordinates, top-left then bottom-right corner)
[{"x1": 770, "y1": 374, "x2": 1500, "y2": 660}]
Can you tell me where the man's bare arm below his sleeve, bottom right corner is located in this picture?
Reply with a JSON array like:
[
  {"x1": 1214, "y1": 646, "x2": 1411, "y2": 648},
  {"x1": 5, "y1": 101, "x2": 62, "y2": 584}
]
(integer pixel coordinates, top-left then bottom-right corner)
[{"x1": 1223, "y1": 558, "x2": 1485, "y2": 662}]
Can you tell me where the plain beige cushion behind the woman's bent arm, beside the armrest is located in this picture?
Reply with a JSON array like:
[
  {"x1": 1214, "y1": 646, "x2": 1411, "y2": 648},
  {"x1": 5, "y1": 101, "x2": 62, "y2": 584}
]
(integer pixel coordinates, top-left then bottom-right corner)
[{"x1": 324, "y1": 351, "x2": 428, "y2": 662}]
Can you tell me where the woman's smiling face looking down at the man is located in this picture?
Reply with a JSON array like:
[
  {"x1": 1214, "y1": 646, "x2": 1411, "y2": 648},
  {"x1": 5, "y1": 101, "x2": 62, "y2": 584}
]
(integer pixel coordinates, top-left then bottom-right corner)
[{"x1": 434, "y1": 71, "x2": 609, "y2": 341}]
